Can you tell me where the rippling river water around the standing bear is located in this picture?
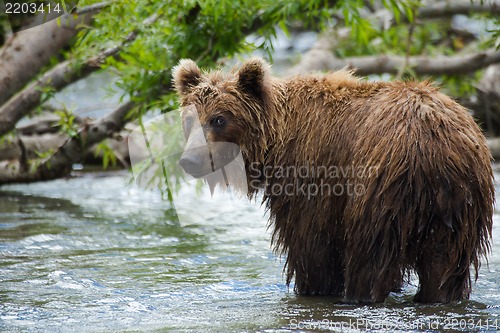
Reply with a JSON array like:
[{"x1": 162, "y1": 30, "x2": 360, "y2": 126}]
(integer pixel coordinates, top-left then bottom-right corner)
[{"x1": 0, "y1": 172, "x2": 500, "y2": 332}]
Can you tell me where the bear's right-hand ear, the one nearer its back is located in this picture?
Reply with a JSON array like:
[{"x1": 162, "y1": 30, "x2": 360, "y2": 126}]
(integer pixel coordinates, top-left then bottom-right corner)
[{"x1": 237, "y1": 58, "x2": 269, "y2": 99}]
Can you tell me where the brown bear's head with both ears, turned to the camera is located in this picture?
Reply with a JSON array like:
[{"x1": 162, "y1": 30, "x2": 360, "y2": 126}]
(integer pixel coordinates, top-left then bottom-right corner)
[{"x1": 173, "y1": 59, "x2": 270, "y2": 177}]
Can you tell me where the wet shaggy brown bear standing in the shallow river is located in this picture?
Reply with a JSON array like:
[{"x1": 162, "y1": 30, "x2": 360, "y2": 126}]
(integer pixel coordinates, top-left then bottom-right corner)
[{"x1": 174, "y1": 59, "x2": 494, "y2": 303}]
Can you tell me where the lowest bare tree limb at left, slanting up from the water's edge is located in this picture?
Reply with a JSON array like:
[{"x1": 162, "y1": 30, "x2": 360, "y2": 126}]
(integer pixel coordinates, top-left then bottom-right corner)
[{"x1": 0, "y1": 101, "x2": 136, "y2": 185}]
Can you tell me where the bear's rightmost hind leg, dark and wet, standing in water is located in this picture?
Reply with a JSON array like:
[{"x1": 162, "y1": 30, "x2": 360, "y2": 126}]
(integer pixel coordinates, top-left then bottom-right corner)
[{"x1": 415, "y1": 221, "x2": 473, "y2": 303}]
